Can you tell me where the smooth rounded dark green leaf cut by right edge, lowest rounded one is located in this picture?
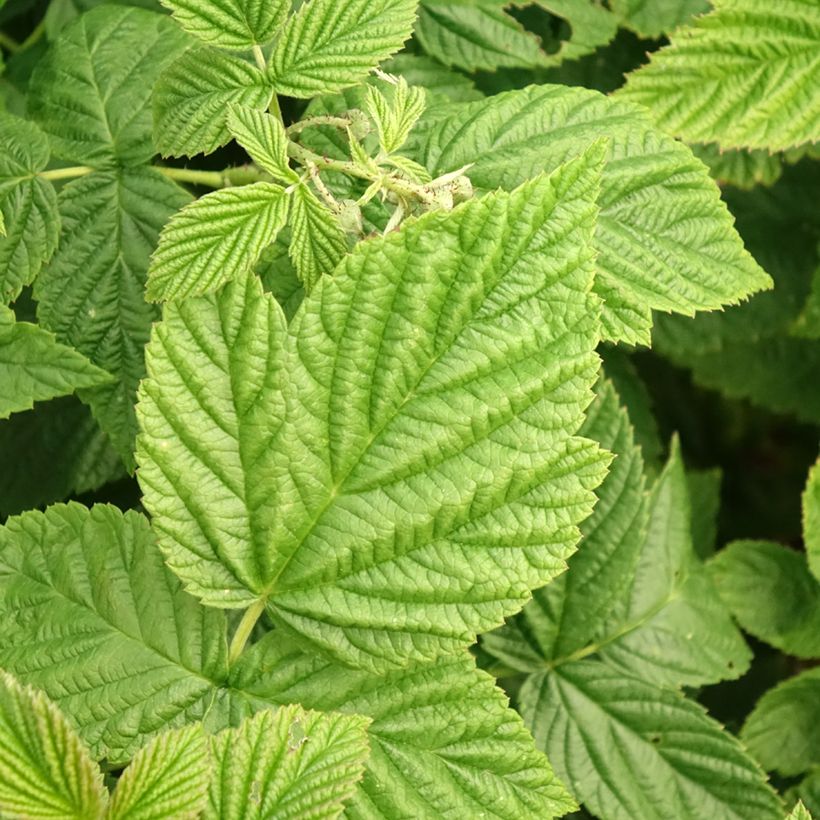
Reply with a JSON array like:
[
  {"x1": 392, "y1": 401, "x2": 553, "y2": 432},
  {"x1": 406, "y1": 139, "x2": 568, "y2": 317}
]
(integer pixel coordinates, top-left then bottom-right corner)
[{"x1": 740, "y1": 667, "x2": 820, "y2": 776}]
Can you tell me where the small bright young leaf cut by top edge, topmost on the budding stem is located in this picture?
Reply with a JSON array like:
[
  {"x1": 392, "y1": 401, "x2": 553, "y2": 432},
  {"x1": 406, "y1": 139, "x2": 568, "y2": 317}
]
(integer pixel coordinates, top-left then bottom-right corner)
[{"x1": 162, "y1": 0, "x2": 290, "y2": 49}]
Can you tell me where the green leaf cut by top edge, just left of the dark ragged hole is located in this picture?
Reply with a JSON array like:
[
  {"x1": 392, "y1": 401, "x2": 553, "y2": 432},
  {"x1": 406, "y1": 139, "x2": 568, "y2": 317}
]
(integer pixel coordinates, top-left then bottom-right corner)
[{"x1": 415, "y1": 0, "x2": 547, "y2": 72}]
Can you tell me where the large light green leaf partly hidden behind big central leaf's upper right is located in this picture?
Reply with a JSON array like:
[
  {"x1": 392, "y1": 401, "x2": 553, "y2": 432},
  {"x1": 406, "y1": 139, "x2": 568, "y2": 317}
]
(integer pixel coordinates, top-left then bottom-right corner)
[{"x1": 411, "y1": 85, "x2": 771, "y2": 344}]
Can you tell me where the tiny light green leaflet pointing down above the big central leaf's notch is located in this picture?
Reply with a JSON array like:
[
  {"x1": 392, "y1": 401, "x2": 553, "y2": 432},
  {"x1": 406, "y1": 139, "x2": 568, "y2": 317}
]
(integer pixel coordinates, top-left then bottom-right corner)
[{"x1": 288, "y1": 185, "x2": 347, "y2": 292}]
